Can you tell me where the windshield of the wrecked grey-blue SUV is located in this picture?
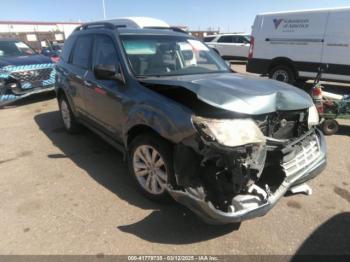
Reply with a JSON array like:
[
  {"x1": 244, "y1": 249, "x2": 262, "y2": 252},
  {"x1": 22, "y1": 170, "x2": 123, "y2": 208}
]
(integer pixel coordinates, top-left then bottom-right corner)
[{"x1": 121, "y1": 35, "x2": 230, "y2": 77}]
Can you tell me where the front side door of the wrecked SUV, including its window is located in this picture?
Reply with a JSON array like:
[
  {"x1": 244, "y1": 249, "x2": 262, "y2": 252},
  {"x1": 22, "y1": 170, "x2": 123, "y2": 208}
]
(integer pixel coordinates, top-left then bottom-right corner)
[{"x1": 85, "y1": 34, "x2": 126, "y2": 140}]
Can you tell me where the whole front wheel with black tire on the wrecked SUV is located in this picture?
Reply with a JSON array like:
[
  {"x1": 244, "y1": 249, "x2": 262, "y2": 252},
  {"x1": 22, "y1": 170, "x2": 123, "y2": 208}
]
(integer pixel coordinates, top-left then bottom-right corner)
[{"x1": 128, "y1": 134, "x2": 174, "y2": 202}]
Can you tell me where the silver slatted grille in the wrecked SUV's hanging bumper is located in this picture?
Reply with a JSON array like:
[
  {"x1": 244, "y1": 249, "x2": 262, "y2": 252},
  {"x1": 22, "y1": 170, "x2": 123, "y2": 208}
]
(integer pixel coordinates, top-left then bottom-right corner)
[{"x1": 282, "y1": 135, "x2": 321, "y2": 177}]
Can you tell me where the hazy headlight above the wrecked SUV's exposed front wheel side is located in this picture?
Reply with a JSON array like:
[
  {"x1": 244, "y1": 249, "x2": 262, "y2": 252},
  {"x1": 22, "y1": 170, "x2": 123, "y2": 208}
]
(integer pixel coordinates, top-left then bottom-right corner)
[{"x1": 192, "y1": 116, "x2": 266, "y2": 147}]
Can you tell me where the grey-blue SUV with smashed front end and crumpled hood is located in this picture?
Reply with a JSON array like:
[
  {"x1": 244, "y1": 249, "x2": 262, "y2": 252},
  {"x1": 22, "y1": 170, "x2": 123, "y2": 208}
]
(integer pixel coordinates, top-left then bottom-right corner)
[{"x1": 56, "y1": 21, "x2": 326, "y2": 224}]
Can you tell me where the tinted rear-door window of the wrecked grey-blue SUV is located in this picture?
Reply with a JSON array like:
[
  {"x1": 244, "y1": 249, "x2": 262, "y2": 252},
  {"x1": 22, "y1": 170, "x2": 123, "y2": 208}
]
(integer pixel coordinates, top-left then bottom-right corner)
[{"x1": 72, "y1": 35, "x2": 93, "y2": 69}]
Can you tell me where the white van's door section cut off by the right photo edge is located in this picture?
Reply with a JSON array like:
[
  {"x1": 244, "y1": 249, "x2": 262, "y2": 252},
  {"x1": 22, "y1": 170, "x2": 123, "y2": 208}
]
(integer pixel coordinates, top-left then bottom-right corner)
[{"x1": 322, "y1": 10, "x2": 350, "y2": 81}]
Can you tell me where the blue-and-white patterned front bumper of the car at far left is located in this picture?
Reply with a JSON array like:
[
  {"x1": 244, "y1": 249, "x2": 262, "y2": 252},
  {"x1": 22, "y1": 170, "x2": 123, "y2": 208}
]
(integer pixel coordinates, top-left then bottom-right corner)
[{"x1": 0, "y1": 64, "x2": 56, "y2": 106}]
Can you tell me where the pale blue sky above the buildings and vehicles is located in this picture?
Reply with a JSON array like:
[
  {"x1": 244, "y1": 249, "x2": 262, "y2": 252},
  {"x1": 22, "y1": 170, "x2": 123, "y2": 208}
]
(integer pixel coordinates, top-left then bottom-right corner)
[{"x1": 0, "y1": 0, "x2": 350, "y2": 33}]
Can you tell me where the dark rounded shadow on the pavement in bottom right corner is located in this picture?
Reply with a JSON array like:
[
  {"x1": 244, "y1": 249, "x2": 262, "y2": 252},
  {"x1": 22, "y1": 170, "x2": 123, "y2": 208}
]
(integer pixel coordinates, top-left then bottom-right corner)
[{"x1": 292, "y1": 213, "x2": 350, "y2": 261}]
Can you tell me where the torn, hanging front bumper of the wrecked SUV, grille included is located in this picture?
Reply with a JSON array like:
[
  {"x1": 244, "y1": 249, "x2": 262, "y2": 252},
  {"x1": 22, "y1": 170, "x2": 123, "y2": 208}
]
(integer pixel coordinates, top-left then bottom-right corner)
[{"x1": 168, "y1": 130, "x2": 327, "y2": 224}]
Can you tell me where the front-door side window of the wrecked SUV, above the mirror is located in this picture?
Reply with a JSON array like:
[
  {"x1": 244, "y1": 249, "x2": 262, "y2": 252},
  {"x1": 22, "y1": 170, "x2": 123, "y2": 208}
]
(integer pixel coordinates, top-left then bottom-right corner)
[{"x1": 94, "y1": 35, "x2": 118, "y2": 66}]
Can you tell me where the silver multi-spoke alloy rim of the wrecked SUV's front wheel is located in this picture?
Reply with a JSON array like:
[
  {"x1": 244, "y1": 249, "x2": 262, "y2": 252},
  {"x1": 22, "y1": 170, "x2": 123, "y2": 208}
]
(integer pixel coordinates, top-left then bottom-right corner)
[{"x1": 133, "y1": 145, "x2": 168, "y2": 195}]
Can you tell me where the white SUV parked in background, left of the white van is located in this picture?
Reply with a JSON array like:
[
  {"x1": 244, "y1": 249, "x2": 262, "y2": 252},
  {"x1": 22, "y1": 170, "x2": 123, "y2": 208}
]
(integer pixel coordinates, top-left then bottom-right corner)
[{"x1": 204, "y1": 34, "x2": 250, "y2": 60}]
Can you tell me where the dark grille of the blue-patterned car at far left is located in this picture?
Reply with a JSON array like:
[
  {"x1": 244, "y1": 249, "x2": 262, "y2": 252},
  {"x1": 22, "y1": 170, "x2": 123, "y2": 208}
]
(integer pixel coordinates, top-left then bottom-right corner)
[{"x1": 11, "y1": 68, "x2": 52, "y2": 86}]
